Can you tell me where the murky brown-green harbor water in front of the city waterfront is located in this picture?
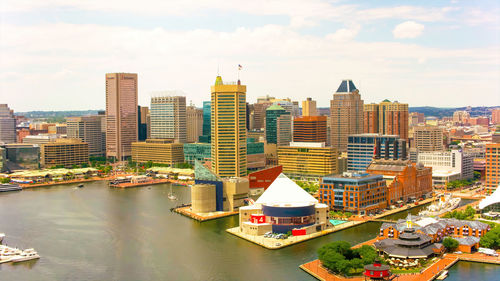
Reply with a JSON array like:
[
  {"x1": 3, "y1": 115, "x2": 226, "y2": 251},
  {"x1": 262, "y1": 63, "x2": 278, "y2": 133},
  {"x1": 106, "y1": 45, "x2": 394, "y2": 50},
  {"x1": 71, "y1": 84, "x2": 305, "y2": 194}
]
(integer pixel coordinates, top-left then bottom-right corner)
[{"x1": 0, "y1": 182, "x2": 500, "y2": 281}]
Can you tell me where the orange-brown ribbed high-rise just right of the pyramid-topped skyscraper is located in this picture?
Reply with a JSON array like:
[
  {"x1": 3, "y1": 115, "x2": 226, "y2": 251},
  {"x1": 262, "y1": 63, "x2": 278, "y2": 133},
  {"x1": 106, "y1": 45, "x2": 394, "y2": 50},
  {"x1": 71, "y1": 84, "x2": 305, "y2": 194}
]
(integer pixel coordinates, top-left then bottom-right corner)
[{"x1": 363, "y1": 99, "x2": 408, "y2": 140}]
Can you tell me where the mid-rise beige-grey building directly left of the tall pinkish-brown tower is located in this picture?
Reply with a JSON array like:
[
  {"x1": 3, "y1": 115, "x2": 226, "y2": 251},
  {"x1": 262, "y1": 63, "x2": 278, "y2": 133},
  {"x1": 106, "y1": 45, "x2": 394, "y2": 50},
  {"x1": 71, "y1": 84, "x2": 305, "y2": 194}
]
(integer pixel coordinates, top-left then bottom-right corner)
[{"x1": 66, "y1": 115, "x2": 106, "y2": 156}]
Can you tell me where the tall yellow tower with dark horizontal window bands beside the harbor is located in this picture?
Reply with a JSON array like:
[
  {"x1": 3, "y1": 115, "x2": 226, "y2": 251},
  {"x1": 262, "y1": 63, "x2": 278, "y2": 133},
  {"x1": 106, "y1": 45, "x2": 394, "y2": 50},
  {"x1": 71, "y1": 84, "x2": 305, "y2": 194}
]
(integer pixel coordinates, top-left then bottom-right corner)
[{"x1": 211, "y1": 76, "x2": 247, "y2": 177}]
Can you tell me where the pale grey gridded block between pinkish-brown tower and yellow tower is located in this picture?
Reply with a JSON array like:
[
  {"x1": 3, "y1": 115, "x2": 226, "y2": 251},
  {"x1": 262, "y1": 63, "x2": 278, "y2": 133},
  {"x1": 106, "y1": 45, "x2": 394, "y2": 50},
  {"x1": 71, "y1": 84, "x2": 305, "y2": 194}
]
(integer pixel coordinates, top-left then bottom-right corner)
[{"x1": 150, "y1": 92, "x2": 186, "y2": 143}]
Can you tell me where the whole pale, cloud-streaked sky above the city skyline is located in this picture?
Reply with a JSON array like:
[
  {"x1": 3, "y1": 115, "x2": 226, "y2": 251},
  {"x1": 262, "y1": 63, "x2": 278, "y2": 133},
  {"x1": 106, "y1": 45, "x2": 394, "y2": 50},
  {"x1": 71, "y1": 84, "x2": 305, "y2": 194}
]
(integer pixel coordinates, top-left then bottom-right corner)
[{"x1": 0, "y1": 0, "x2": 500, "y2": 111}]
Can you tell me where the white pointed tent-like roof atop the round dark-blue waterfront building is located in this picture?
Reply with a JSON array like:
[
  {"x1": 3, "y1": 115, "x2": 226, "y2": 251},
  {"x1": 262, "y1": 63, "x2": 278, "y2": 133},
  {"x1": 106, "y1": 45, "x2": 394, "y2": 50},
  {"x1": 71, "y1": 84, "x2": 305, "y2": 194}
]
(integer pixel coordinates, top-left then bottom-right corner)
[{"x1": 255, "y1": 174, "x2": 318, "y2": 206}]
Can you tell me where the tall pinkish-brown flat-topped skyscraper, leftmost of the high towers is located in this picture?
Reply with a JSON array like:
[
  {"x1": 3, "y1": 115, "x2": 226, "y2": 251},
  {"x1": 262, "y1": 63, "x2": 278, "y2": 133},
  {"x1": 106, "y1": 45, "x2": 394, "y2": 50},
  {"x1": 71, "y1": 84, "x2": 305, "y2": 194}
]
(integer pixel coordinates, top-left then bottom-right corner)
[{"x1": 106, "y1": 73, "x2": 138, "y2": 160}]
